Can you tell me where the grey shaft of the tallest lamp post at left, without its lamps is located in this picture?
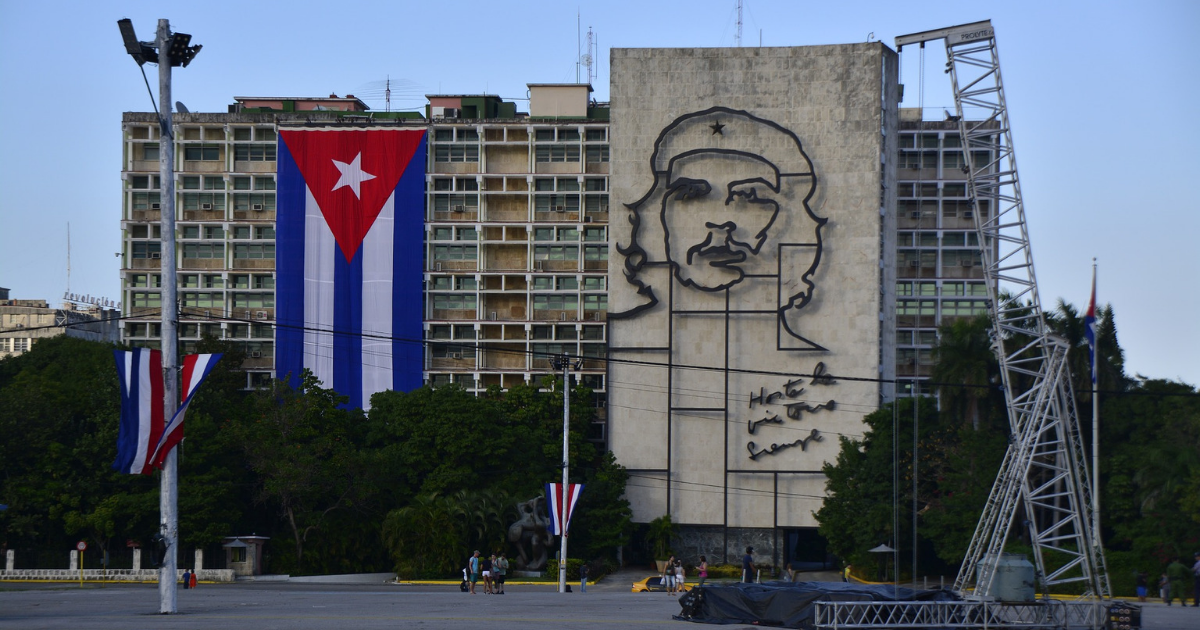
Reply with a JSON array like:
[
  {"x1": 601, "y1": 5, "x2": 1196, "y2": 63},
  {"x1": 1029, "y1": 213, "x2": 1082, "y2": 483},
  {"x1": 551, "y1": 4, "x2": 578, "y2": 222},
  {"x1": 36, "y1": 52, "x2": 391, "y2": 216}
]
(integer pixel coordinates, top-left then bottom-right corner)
[{"x1": 155, "y1": 19, "x2": 179, "y2": 614}]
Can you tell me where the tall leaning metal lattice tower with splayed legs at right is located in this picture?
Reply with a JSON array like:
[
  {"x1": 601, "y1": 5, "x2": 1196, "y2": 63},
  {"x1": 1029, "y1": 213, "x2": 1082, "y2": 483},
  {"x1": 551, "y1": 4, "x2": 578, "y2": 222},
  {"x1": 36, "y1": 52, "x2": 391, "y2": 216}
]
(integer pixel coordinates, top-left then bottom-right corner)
[{"x1": 895, "y1": 20, "x2": 1111, "y2": 600}]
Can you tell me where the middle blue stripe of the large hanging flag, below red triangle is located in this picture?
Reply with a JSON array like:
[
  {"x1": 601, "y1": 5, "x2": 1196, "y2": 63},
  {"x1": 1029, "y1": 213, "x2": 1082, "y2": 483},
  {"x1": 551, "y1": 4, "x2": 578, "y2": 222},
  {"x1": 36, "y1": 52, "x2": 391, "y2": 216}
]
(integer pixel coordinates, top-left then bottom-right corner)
[{"x1": 336, "y1": 241, "x2": 362, "y2": 409}]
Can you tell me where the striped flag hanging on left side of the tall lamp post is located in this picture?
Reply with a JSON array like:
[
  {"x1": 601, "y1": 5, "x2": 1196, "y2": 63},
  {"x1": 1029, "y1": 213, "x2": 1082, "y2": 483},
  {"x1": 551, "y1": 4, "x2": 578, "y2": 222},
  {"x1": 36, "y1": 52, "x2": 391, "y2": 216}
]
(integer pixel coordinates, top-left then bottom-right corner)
[{"x1": 113, "y1": 348, "x2": 163, "y2": 475}]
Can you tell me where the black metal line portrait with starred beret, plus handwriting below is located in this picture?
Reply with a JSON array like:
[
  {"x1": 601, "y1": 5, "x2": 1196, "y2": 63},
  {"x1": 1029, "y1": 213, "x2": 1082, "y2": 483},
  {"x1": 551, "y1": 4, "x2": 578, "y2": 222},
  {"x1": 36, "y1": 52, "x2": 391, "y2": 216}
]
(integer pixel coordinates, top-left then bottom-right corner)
[{"x1": 608, "y1": 107, "x2": 836, "y2": 461}]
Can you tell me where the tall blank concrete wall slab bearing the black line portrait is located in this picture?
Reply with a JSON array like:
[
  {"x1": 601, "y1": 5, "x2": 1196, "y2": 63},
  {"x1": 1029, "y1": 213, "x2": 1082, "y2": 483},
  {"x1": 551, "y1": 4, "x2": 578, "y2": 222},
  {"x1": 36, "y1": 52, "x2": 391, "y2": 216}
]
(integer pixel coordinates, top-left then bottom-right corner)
[{"x1": 608, "y1": 43, "x2": 899, "y2": 560}]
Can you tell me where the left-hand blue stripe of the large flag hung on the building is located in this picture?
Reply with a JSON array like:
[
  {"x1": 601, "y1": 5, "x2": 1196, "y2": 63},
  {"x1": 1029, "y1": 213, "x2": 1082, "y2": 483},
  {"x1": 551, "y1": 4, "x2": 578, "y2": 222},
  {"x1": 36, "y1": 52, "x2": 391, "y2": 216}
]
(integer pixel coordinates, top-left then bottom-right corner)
[{"x1": 275, "y1": 140, "x2": 306, "y2": 385}]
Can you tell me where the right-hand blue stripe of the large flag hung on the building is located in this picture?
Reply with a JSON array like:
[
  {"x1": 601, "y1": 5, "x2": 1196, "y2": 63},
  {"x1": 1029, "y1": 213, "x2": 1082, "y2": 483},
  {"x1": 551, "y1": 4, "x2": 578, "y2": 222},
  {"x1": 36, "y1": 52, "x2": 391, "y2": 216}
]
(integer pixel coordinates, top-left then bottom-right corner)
[{"x1": 391, "y1": 138, "x2": 426, "y2": 391}]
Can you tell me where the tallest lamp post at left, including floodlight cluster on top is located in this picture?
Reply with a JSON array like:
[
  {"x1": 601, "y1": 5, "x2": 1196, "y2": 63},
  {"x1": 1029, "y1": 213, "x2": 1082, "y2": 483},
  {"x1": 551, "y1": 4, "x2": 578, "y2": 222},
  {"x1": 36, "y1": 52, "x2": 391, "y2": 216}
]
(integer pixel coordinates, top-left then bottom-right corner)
[{"x1": 116, "y1": 19, "x2": 202, "y2": 614}]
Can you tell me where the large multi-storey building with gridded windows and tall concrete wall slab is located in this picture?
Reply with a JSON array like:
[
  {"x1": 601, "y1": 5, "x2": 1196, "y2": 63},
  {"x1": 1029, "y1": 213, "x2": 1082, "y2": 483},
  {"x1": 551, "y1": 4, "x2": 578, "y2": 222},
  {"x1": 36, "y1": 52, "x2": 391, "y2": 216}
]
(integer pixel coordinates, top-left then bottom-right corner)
[{"x1": 121, "y1": 42, "x2": 988, "y2": 562}]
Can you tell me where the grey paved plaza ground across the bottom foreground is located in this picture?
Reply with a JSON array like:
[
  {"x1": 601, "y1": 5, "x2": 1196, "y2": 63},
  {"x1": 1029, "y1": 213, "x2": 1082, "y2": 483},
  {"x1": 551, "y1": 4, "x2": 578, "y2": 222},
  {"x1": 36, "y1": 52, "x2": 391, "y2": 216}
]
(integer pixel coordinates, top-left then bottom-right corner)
[{"x1": 0, "y1": 572, "x2": 1200, "y2": 630}]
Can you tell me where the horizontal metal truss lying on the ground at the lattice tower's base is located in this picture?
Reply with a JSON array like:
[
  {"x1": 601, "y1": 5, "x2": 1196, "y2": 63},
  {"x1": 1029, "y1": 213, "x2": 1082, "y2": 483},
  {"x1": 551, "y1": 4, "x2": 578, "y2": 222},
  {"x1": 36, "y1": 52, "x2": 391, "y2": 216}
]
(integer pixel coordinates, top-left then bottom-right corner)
[{"x1": 814, "y1": 600, "x2": 1104, "y2": 630}]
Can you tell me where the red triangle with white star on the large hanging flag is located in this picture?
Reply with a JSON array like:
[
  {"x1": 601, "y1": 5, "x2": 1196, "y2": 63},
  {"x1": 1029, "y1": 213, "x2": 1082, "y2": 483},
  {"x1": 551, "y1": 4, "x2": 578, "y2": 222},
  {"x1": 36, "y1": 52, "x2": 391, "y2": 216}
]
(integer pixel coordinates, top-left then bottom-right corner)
[{"x1": 280, "y1": 128, "x2": 425, "y2": 262}]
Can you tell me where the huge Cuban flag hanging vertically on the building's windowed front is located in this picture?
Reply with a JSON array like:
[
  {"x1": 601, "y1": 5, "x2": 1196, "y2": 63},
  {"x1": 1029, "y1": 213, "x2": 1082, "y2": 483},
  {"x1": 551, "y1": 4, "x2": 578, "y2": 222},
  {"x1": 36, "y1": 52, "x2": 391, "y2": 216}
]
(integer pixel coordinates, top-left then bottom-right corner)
[{"x1": 275, "y1": 127, "x2": 426, "y2": 408}]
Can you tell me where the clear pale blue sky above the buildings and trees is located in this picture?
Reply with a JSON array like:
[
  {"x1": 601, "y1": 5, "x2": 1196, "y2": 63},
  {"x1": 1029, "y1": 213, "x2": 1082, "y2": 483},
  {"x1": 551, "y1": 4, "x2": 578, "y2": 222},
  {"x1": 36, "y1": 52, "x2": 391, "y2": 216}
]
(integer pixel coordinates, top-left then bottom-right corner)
[{"x1": 0, "y1": 0, "x2": 1200, "y2": 385}]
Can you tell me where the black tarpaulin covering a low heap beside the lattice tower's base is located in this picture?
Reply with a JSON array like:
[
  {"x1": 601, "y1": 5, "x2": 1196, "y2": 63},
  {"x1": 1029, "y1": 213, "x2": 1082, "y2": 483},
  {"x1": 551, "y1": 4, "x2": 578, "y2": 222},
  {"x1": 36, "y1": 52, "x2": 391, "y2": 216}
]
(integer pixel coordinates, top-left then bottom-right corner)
[{"x1": 674, "y1": 582, "x2": 958, "y2": 629}]
